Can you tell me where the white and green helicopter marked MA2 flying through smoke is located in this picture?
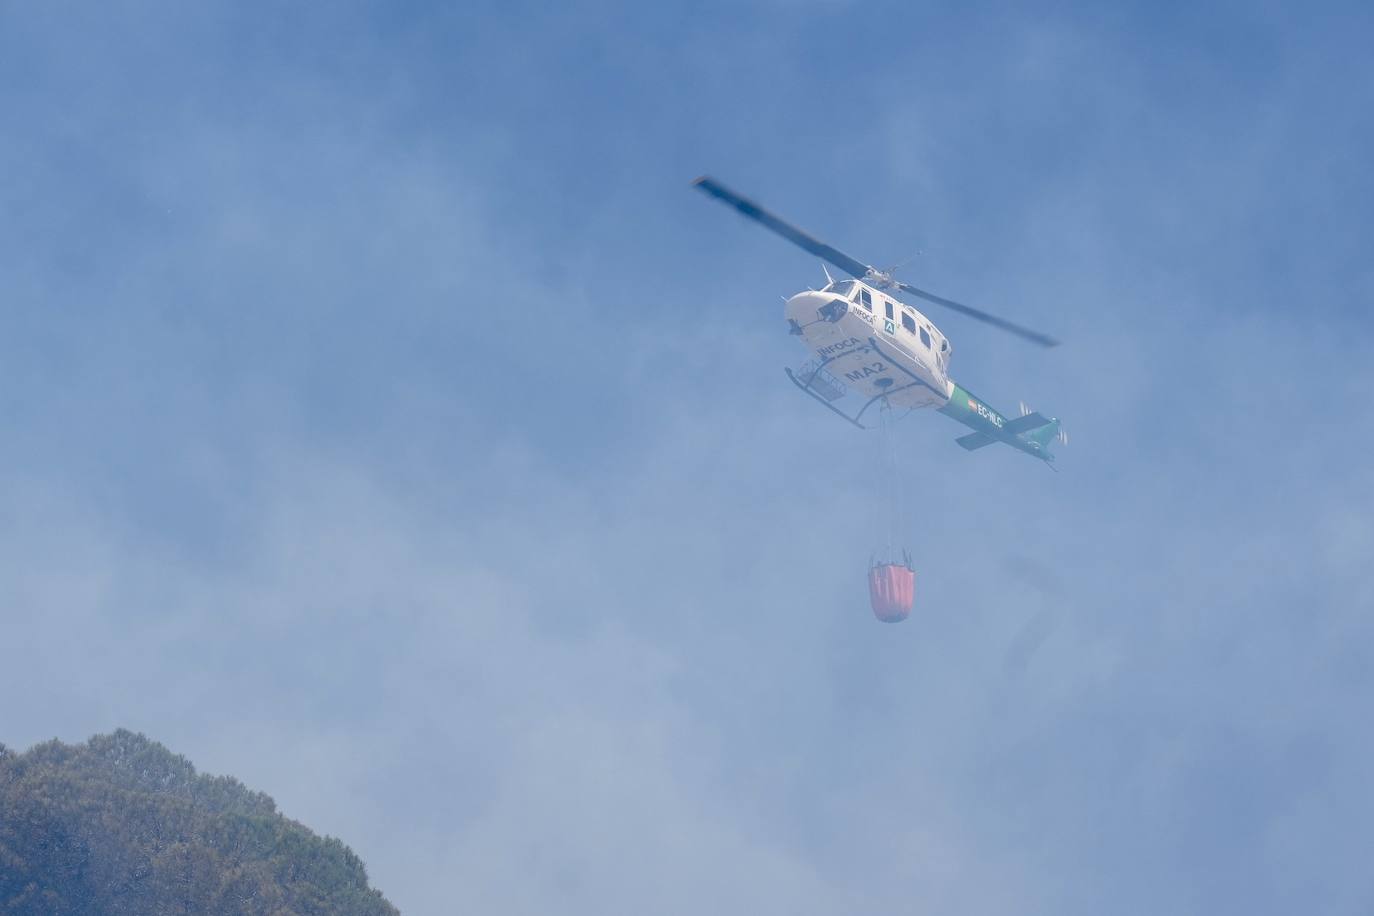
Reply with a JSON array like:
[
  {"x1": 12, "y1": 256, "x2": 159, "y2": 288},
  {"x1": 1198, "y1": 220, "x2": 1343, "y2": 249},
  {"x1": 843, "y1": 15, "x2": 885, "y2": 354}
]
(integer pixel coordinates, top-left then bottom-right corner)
[{"x1": 692, "y1": 176, "x2": 1069, "y2": 464}]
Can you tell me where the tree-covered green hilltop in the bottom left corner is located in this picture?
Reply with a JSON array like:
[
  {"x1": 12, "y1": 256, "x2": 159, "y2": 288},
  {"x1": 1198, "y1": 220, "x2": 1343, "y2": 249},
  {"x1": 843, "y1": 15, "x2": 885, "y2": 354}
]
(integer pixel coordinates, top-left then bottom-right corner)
[{"x1": 0, "y1": 729, "x2": 397, "y2": 916}]
